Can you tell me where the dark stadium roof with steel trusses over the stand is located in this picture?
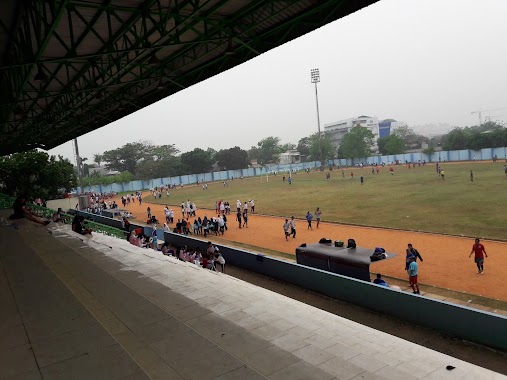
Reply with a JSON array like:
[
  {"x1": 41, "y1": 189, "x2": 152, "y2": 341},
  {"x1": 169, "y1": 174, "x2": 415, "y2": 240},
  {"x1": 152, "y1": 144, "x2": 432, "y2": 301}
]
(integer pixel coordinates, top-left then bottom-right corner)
[{"x1": 0, "y1": 0, "x2": 378, "y2": 155}]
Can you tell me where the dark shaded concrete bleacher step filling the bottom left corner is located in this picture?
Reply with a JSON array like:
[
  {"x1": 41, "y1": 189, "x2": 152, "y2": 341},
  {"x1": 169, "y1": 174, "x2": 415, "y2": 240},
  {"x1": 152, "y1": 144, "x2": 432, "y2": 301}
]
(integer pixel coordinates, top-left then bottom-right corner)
[{"x1": 0, "y1": 226, "x2": 148, "y2": 379}]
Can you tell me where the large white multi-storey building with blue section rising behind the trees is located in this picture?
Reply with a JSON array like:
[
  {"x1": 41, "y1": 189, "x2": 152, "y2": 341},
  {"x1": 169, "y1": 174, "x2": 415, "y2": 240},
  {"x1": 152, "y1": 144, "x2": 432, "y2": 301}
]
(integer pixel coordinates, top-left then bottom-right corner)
[{"x1": 324, "y1": 115, "x2": 405, "y2": 152}]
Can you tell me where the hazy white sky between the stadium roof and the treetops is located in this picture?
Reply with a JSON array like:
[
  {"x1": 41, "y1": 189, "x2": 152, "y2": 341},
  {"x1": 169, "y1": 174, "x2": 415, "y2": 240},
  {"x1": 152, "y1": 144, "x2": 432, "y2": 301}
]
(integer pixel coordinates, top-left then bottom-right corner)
[{"x1": 49, "y1": 0, "x2": 507, "y2": 161}]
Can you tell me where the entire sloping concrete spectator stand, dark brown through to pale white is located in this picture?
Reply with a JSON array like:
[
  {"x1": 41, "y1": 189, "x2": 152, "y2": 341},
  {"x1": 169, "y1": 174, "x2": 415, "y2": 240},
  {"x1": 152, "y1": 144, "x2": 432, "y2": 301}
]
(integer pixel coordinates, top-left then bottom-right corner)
[{"x1": 0, "y1": 217, "x2": 507, "y2": 380}]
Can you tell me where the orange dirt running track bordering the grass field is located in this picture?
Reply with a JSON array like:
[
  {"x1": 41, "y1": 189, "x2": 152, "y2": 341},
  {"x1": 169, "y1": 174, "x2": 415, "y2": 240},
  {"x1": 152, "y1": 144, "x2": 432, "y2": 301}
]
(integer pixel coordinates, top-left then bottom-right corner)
[{"x1": 115, "y1": 192, "x2": 507, "y2": 301}]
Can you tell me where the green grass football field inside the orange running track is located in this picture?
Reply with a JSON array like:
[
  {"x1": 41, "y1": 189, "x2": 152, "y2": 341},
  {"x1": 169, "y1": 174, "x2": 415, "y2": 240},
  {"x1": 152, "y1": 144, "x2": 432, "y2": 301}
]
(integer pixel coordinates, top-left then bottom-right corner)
[{"x1": 145, "y1": 162, "x2": 507, "y2": 239}]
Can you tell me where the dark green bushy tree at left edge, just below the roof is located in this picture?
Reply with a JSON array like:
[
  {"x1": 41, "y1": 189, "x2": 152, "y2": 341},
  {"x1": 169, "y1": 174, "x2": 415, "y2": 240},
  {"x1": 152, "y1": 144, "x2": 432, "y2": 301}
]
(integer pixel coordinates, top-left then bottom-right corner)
[{"x1": 0, "y1": 150, "x2": 77, "y2": 199}]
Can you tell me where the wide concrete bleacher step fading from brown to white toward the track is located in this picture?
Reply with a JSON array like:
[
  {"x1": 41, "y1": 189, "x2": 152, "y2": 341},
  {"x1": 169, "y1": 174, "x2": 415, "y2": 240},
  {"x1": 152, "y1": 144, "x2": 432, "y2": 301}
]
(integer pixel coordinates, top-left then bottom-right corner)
[{"x1": 7, "y1": 221, "x2": 505, "y2": 380}]
